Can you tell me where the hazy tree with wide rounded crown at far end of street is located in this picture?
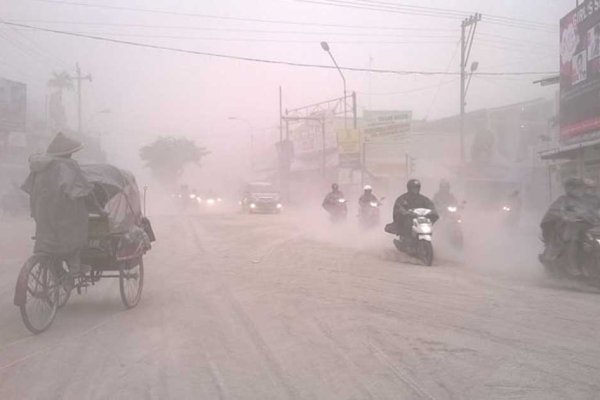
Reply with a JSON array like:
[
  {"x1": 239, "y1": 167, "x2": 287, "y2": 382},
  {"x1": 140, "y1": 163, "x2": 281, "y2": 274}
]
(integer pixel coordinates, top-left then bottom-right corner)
[{"x1": 140, "y1": 136, "x2": 210, "y2": 184}]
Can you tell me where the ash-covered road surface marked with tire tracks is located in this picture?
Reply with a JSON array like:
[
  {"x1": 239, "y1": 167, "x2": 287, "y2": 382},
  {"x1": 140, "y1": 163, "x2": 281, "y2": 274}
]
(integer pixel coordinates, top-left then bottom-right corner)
[{"x1": 0, "y1": 214, "x2": 600, "y2": 400}]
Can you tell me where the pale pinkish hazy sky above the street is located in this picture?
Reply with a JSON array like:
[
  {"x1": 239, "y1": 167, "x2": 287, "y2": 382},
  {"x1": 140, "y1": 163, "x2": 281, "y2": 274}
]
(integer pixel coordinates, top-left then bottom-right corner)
[{"x1": 0, "y1": 0, "x2": 575, "y2": 170}]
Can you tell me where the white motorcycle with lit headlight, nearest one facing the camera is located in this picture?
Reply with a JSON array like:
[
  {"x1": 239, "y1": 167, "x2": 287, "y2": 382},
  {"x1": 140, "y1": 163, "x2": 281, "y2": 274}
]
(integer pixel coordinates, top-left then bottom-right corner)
[{"x1": 385, "y1": 208, "x2": 433, "y2": 267}]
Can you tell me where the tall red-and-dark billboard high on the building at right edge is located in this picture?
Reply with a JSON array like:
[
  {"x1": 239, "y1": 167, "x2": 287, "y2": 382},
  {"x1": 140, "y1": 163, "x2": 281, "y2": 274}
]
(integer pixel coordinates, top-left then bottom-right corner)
[{"x1": 559, "y1": 0, "x2": 600, "y2": 143}]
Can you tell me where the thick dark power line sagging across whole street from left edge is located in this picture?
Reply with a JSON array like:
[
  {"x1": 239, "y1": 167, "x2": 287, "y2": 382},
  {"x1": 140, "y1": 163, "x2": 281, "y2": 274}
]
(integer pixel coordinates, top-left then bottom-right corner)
[{"x1": 0, "y1": 20, "x2": 557, "y2": 76}]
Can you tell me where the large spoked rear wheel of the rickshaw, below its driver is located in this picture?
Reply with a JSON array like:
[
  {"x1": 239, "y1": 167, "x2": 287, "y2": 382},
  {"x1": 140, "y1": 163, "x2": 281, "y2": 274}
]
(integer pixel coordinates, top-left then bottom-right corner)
[{"x1": 19, "y1": 256, "x2": 60, "y2": 334}]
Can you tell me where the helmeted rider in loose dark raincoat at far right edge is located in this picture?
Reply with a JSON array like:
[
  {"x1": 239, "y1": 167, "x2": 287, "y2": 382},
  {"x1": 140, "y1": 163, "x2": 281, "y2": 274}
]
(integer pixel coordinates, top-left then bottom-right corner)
[{"x1": 540, "y1": 178, "x2": 598, "y2": 275}]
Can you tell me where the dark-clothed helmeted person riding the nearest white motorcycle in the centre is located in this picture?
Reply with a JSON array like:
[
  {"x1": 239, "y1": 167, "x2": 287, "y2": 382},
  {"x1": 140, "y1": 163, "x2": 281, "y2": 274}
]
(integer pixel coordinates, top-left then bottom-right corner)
[{"x1": 393, "y1": 179, "x2": 439, "y2": 242}]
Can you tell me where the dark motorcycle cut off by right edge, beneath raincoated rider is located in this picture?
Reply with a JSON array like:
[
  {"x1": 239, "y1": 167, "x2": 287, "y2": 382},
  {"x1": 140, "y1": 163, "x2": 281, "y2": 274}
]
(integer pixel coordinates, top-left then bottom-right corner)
[{"x1": 539, "y1": 214, "x2": 600, "y2": 287}]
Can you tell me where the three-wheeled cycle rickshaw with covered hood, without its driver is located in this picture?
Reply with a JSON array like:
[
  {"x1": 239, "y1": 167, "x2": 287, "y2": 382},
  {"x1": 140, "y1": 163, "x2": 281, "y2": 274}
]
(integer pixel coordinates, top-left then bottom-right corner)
[{"x1": 14, "y1": 164, "x2": 155, "y2": 334}]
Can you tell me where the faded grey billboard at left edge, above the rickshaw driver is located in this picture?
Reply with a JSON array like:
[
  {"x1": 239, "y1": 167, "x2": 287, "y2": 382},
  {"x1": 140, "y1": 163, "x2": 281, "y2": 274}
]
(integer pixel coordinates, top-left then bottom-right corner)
[{"x1": 0, "y1": 78, "x2": 27, "y2": 132}]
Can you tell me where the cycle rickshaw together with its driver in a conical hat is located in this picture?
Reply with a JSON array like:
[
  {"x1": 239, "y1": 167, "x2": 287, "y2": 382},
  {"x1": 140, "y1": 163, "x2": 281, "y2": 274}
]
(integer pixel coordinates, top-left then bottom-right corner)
[{"x1": 14, "y1": 133, "x2": 154, "y2": 333}]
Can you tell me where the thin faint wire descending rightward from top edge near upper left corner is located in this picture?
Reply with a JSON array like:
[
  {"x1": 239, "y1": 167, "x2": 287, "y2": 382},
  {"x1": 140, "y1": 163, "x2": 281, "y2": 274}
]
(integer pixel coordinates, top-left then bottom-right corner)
[{"x1": 31, "y1": 0, "x2": 454, "y2": 31}]
